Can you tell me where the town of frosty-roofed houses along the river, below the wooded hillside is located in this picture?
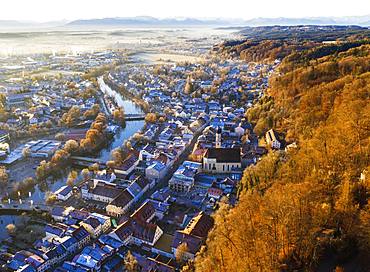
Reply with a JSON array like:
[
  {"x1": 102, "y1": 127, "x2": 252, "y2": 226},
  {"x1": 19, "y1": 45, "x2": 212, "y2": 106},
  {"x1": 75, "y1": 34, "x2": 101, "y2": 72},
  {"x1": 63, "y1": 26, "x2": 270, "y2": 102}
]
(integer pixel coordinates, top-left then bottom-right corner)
[{"x1": 0, "y1": 39, "x2": 282, "y2": 272}]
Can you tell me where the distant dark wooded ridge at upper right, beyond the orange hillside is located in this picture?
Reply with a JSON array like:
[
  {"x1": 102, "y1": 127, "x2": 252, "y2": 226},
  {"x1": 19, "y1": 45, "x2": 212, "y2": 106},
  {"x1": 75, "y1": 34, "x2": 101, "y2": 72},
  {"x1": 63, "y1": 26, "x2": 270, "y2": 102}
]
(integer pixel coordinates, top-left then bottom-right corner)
[{"x1": 213, "y1": 26, "x2": 370, "y2": 63}]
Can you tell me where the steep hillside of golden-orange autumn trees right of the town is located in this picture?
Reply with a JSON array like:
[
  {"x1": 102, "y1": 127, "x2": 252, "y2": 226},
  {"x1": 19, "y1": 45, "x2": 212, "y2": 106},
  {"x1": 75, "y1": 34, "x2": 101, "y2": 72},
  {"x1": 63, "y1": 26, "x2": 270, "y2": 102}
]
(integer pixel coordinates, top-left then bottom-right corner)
[{"x1": 195, "y1": 42, "x2": 370, "y2": 272}]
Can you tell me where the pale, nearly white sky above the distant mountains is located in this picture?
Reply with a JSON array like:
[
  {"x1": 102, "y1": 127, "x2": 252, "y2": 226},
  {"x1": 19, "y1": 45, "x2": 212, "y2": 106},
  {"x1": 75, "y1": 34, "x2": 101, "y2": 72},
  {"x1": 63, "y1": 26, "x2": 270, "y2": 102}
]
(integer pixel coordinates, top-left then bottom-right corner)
[{"x1": 0, "y1": 0, "x2": 370, "y2": 22}]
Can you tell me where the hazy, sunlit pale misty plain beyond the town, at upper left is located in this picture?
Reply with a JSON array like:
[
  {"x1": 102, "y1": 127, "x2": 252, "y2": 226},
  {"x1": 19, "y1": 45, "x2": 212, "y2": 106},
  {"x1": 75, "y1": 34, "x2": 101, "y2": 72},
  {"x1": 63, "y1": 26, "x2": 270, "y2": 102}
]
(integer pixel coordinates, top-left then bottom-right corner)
[{"x1": 0, "y1": 27, "x2": 233, "y2": 59}]
